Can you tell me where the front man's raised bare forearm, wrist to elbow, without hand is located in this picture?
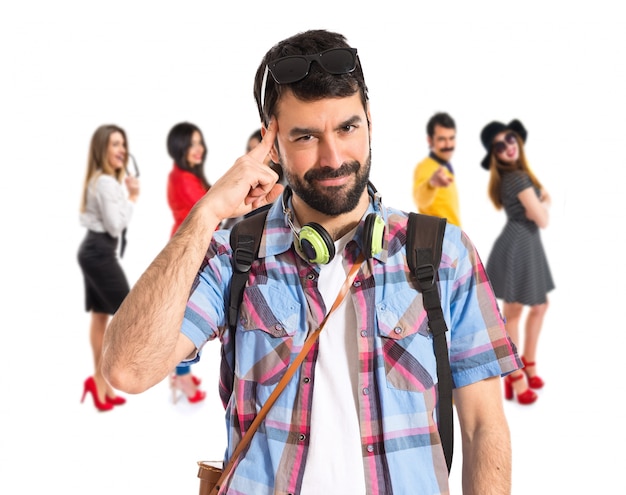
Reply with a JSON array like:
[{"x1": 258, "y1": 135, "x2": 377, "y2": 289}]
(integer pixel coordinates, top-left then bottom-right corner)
[{"x1": 102, "y1": 208, "x2": 217, "y2": 393}]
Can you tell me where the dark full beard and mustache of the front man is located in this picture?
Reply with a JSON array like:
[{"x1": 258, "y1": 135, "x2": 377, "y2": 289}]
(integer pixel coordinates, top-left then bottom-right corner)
[{"x1": 283, "y1": 149, "x2": 372, "y2": 217}]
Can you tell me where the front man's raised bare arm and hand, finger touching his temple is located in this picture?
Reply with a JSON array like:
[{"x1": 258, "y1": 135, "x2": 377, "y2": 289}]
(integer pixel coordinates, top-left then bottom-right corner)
[{"x1": 102, "y1": 119, "x2": 283, "y2": 393}]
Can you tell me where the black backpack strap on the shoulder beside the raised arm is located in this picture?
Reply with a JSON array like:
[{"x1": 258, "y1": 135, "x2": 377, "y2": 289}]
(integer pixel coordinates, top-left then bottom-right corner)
[{"x1": 228, "y1": 205, "x2": 271, "y2": 332}]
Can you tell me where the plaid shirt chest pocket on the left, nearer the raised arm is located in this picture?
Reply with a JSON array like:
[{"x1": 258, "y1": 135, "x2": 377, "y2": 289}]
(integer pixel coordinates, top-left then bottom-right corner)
[{"x1": 235, "y1": 285, "x2": 305, "y2": 385}]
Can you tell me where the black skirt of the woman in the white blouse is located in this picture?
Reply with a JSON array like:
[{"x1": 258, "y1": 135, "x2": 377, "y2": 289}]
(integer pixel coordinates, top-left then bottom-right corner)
[{"x1": 78, "y1": 230, "x2": 130, "y2": 315}]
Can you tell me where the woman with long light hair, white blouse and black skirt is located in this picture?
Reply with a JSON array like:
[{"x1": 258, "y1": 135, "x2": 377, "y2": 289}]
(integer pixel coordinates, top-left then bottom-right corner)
[{"x1": 78, "y1": 125, "x2": 139, "y2": 411}]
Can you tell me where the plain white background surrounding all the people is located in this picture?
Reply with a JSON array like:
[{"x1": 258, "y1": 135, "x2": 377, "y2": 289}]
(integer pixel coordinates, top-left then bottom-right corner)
[{"x1": 0, "y1": 0, "x2": 626, "y2": 495}]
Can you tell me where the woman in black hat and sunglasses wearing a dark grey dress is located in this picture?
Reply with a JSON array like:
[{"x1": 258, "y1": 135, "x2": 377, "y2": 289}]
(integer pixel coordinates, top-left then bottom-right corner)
[{"x1": 480, "y1": 120, "x2": 554, "y2": 404}]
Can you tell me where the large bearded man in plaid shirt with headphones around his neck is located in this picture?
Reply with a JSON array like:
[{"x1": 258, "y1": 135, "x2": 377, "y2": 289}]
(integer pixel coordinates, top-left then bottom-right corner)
[{"x1": 103, "y1": 30, "x2": 521, "y2": 495}]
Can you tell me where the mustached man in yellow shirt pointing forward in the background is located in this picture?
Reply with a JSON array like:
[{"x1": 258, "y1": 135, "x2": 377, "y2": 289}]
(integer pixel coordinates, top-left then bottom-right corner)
[{"x1": 413, "y1": 112, "x2": 461, "y2": 227}]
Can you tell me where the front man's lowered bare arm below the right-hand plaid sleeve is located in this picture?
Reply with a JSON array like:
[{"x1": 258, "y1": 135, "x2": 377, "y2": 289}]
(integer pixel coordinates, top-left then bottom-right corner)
[{"x1": 453, "y1": 376, "x2": 512, "y2": 495}]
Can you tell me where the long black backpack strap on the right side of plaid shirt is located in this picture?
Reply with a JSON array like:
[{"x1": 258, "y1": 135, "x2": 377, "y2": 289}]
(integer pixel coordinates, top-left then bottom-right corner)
[{"x1": 406, "y1": 212, "x2": 454, "y2": 473}]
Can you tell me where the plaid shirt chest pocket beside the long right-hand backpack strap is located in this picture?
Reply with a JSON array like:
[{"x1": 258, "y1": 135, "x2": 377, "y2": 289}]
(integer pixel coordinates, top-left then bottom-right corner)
[{"x1": 376, "y1": 289, "x2": 436, "y2": 392}]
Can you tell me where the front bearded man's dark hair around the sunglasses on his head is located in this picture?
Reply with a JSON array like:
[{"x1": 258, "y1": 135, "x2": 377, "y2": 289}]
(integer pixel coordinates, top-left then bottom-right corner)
[{"x1": 254, "y1": 29, "x2": 368, "y2": 125}]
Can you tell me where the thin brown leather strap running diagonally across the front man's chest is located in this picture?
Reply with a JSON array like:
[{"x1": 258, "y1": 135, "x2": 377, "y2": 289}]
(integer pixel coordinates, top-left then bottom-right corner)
[{"x1": 211, "y1": 254, "x2": 365, "y2": 495}]
